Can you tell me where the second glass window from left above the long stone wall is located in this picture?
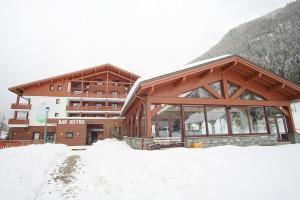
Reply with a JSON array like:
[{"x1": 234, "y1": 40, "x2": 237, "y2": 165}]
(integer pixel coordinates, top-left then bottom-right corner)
[{"x1": 206, "y1": 106, "x2": 228, "y2": 134}]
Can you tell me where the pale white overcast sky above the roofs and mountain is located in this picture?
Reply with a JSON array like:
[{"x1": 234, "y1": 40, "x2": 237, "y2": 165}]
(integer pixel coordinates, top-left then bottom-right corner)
[{"x1": 0, "y1": 0, "x2": 291, "y2": 115}]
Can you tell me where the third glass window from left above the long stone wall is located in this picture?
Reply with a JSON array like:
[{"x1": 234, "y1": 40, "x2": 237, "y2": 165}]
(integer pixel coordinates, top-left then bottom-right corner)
[{"x1": 230, "y1": 107, "x2": 250, "y2": 134}]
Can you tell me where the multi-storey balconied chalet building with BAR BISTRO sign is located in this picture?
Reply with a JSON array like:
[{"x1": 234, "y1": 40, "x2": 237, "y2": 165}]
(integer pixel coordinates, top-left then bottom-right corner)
[{"x1": 8, "y1": 64, "x2": 139, "y2": 145}]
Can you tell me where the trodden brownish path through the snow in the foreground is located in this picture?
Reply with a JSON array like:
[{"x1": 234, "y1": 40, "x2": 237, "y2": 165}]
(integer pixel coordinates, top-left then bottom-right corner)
[{"x1": 36, "y1": 154, "x2": 84, "y2": 200}]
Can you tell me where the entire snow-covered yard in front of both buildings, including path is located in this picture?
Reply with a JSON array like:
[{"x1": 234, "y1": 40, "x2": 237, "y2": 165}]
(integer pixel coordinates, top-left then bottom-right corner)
[{"x1": 0, "y1": 140, "x2": 300, "y2": 200}]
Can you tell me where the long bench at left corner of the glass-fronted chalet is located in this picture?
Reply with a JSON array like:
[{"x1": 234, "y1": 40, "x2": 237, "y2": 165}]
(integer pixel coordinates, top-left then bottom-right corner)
[{"x1": 149, "y1": 137, "x2": 184, "y2": 150}]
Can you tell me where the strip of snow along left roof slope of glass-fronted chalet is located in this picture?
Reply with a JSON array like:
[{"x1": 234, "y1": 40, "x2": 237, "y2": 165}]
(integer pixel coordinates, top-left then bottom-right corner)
[{"x1": 121, "y1": 54, "x2": 233, "y2": 114}]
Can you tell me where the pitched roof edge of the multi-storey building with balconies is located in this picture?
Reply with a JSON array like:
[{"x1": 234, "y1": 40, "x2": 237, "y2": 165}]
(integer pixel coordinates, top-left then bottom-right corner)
[{"x1": 8, "y1": 63, "x2": 140, "y2": 93}]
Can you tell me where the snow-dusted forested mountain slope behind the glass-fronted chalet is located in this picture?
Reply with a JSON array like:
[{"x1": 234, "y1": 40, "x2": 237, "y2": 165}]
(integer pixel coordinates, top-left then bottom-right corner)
[{"x1": 192, "y1": 0, "x2": 300, "y2": 84}]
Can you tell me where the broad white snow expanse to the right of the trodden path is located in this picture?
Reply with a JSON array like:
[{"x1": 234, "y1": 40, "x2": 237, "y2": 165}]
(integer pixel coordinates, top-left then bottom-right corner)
[{"x1": 75, "y1": 140, "x2": 300, "y2": 200}]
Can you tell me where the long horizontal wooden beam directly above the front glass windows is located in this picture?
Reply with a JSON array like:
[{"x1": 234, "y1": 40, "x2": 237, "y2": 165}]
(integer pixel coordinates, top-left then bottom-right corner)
[{"x1": 148, "y1": 97, "x2": 290, "y2": 106}]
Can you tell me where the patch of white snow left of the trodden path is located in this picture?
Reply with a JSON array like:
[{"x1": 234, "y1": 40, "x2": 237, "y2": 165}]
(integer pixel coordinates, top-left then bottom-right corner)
[{"x1": 0, "y1": 144, "x2": 70, "y2": 200}]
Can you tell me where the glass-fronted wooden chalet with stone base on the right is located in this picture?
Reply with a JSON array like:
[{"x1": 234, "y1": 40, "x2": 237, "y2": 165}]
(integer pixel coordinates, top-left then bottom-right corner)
[{"x1": 121, "y1": 55, "x2": 300, "y2": 148}]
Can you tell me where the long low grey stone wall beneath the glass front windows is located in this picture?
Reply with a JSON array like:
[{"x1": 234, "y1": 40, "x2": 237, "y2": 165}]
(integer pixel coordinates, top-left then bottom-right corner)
[{"x1": 184, "y1": 135, "x2": 277, "y2": 148}]
